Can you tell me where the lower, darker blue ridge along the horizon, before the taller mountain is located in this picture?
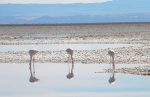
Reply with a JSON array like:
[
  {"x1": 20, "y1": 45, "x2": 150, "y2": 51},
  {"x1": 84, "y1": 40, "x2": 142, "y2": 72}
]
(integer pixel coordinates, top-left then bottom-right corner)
[{"x1": 0, "y1": 13, "x2": 150, "y2": 24}]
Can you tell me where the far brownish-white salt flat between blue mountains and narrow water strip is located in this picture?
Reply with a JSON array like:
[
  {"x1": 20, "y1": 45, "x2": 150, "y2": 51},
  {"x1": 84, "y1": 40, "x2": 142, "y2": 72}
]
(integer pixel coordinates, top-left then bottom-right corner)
[{"x1": 0, "y1": 23, "x2": 150, "y2": 45}]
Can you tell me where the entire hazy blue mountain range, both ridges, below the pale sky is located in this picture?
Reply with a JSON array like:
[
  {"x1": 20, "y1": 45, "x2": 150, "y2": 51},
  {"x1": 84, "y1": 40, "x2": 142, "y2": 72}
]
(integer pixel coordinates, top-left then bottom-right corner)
[{"x1": 0, "y1": 0, "x2": 150, "y2": 24}]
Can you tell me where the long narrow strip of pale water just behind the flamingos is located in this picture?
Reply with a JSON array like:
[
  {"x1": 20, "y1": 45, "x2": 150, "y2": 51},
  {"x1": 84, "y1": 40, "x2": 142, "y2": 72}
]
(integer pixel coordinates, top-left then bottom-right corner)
[{"x1": 0, "y1": 44, "x2": 140, "y2": 52}]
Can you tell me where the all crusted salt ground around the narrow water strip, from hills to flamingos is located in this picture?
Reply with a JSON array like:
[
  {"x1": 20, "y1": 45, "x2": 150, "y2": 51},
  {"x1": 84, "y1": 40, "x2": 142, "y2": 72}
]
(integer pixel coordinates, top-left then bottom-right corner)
[{"x1": 0, "y1": 23, "x2": 150, "y2": 64}]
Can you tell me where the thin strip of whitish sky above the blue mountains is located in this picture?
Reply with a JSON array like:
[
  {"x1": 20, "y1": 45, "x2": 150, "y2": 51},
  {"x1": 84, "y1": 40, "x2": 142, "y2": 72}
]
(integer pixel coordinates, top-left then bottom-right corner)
[{"x1": 0, "y1": 0, "x2": 113, "y2": 4}]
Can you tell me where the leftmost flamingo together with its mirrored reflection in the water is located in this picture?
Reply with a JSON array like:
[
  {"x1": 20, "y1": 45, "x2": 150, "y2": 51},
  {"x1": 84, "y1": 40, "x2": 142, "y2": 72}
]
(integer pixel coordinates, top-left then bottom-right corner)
[{"x1": 29, "y1": 49, "x2": 39, "y2": 83}]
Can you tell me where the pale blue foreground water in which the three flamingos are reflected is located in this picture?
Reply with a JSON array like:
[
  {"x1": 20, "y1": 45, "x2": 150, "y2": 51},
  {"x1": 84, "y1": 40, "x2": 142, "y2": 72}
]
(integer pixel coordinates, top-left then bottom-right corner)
[{"x1": 0, "y1": 63, "x2": 150, "y2": 97}]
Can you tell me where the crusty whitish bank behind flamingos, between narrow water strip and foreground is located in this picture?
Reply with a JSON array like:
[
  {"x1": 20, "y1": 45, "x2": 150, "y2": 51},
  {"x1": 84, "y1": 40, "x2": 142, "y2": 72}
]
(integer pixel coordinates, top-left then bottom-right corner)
[{"x1": 0, "y1": 45, "x2": 150, "y2": 64}]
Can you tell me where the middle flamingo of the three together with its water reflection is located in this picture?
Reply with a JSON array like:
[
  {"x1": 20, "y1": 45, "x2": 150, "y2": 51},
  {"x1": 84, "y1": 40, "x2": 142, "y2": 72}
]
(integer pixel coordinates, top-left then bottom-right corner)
[{"x1": 66, "y1": 48, "x2": 74, "y2": 79}]
